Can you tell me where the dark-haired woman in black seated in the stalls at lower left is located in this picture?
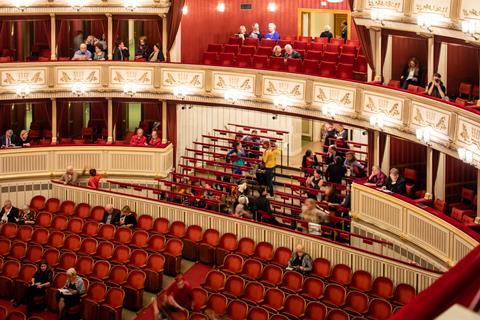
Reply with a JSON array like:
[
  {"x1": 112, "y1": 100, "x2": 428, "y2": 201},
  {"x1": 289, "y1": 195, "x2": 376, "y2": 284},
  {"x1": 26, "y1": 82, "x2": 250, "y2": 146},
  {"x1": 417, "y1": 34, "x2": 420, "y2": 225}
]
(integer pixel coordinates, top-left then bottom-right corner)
[{"x1": 14, "y1": 260, "x2": 53, "y2": 316}]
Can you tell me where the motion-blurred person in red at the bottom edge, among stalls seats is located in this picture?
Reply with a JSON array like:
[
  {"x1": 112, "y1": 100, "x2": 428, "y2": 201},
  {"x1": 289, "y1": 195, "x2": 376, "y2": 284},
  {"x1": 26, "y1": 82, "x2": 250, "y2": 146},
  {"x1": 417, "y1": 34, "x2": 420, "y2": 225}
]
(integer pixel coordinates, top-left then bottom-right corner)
[{"x1": 152, "y1": 273, "x2": 193, "y2": 320}]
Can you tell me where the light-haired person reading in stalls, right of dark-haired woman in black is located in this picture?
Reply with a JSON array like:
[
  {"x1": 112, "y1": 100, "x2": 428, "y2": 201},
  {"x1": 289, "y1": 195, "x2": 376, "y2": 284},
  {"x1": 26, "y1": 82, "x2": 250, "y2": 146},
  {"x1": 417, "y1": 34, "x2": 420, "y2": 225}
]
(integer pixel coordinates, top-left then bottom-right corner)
[{"x1": 57, "y1": 268, "x2": 85, "y2": 319}]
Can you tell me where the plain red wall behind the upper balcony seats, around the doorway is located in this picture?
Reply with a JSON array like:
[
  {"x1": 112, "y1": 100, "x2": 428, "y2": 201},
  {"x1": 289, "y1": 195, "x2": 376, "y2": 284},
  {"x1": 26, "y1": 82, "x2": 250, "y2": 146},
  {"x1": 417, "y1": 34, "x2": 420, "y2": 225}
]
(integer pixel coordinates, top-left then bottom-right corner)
[{"x1": 181, "y1": 0, "x2": 357, "y2": 63}]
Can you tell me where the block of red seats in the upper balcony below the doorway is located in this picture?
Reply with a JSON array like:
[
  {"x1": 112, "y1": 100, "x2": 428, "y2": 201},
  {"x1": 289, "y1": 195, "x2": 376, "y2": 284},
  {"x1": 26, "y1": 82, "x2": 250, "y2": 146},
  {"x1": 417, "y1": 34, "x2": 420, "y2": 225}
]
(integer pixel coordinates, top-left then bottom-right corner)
[{"x1": 203, "y1": 37, "x2": 367, "y2": 81}]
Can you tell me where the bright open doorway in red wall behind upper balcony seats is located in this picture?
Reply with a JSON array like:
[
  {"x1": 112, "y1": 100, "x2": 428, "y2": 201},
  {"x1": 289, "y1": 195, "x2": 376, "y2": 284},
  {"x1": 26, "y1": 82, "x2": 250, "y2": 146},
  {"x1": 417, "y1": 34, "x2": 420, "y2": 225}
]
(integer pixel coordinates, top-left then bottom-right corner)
[{"x1": 298, "y1": 9, "x2": 350, "y2": 39}]
